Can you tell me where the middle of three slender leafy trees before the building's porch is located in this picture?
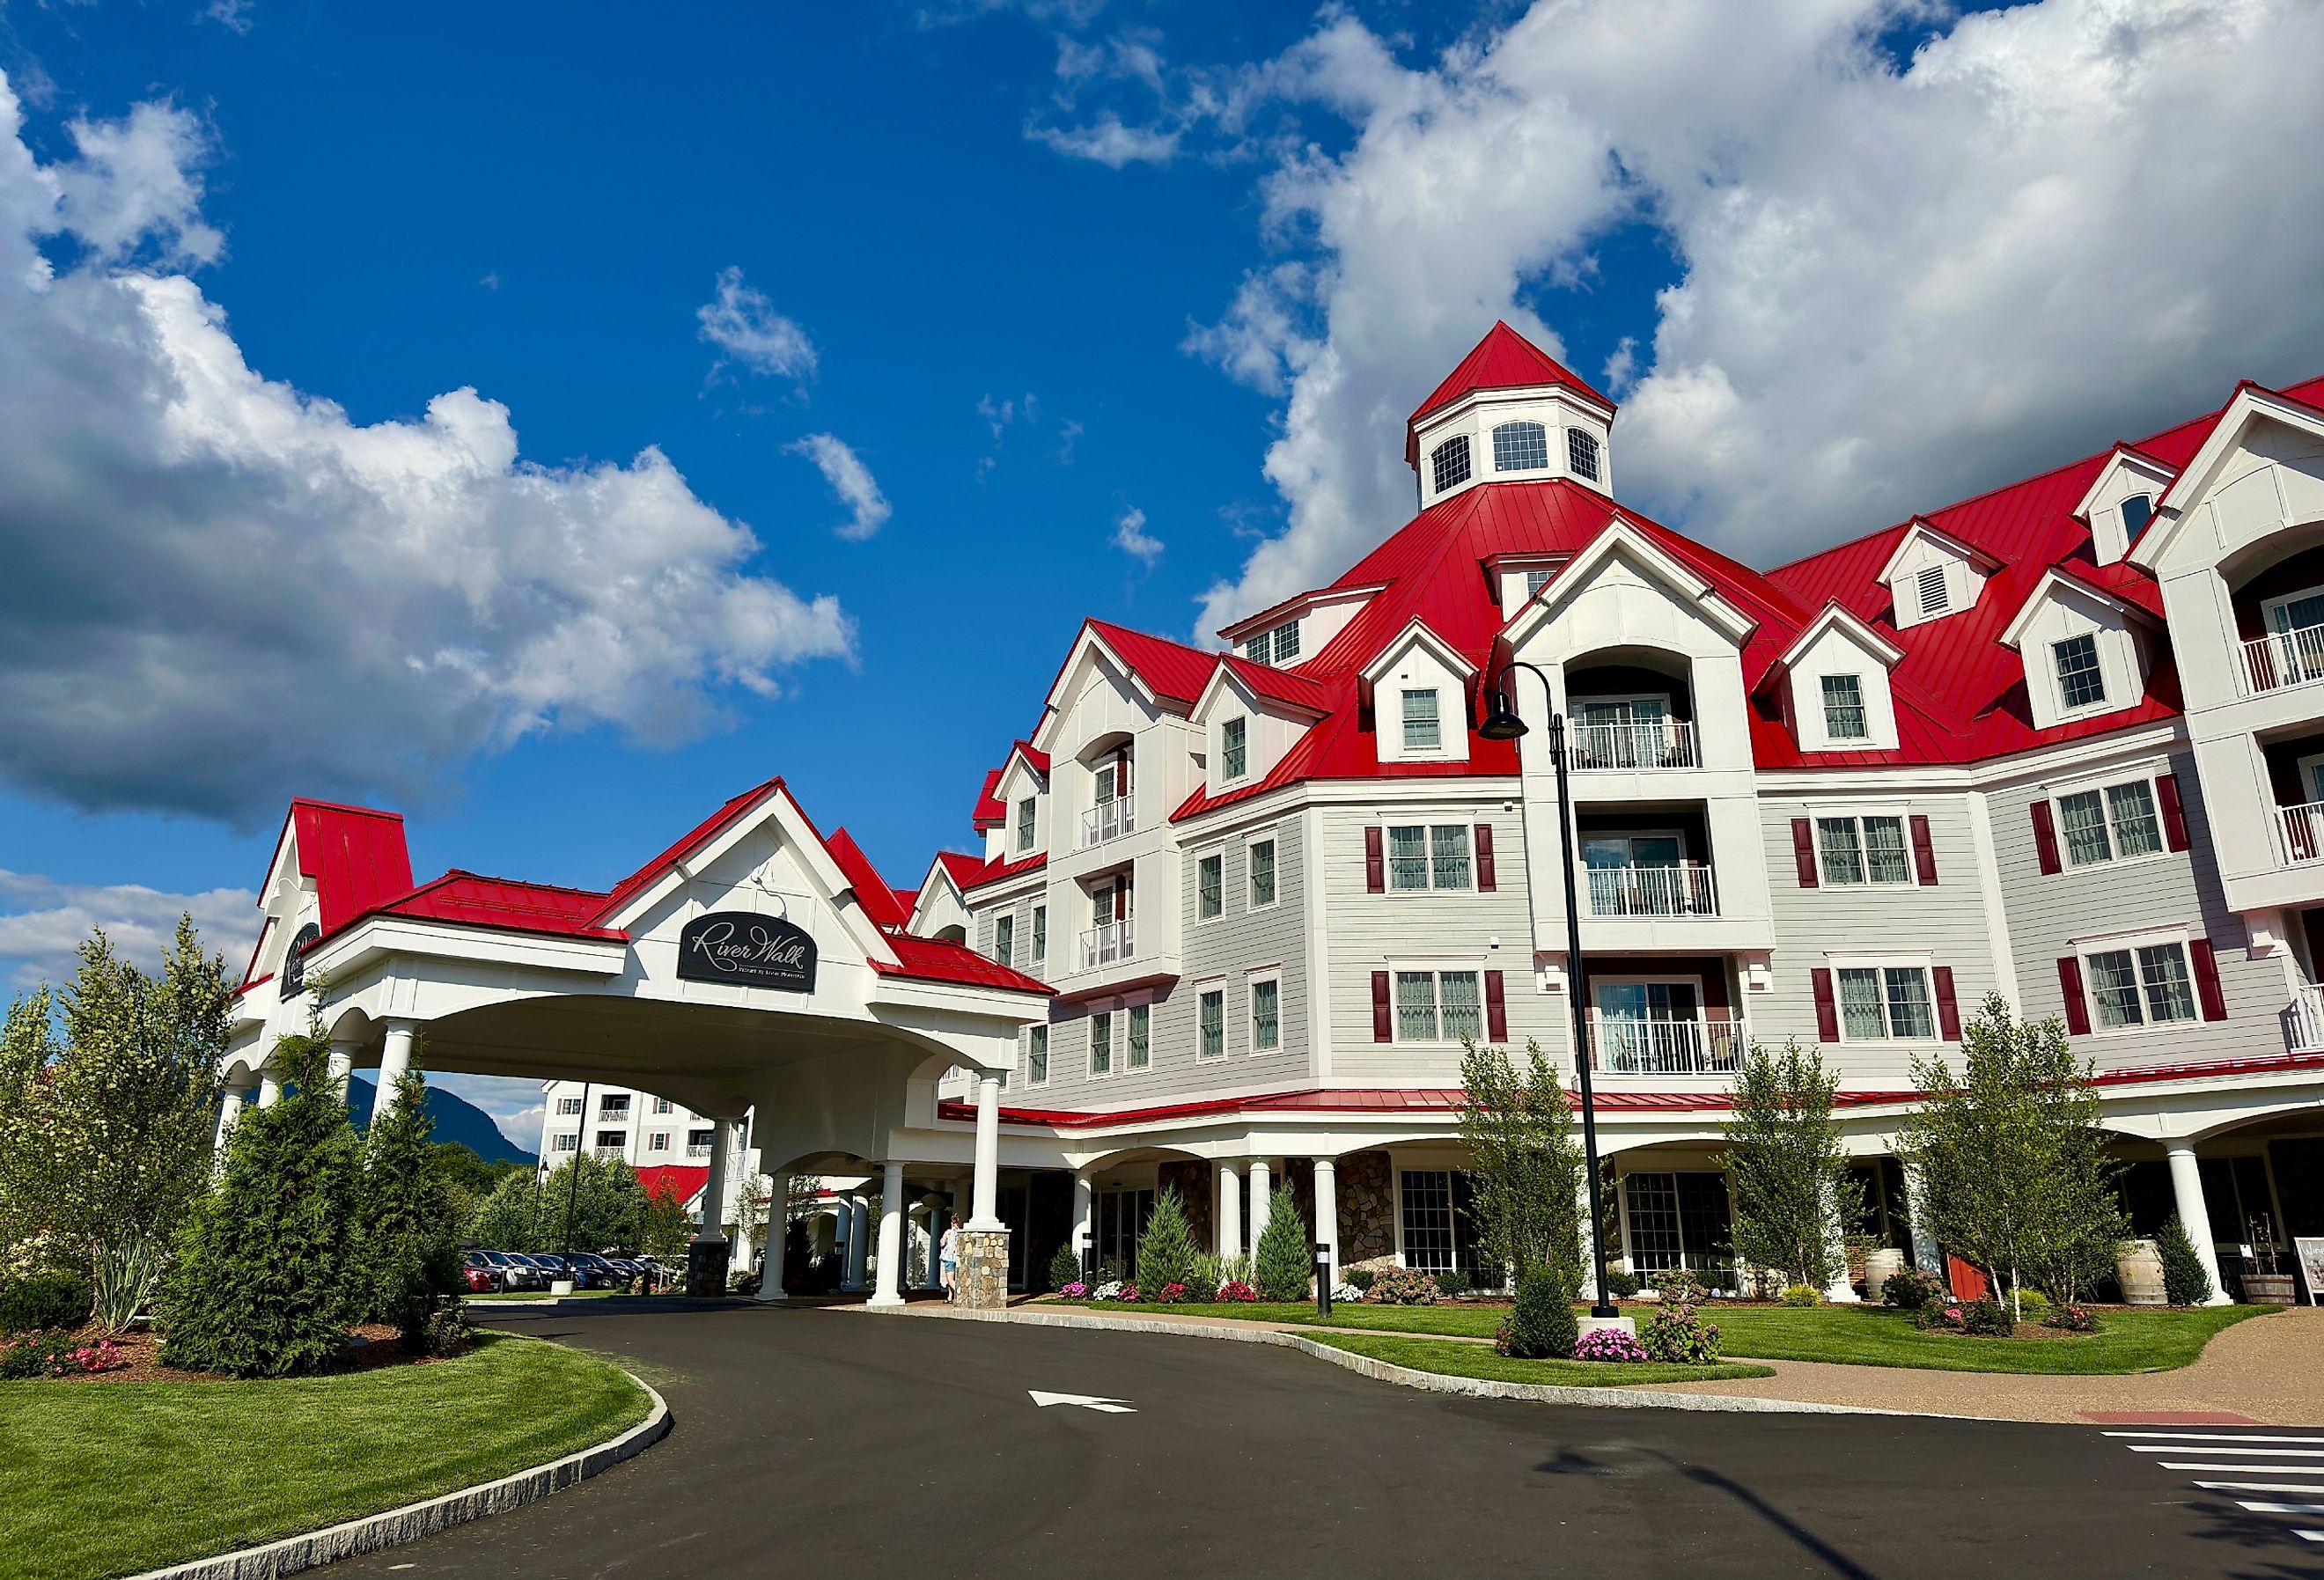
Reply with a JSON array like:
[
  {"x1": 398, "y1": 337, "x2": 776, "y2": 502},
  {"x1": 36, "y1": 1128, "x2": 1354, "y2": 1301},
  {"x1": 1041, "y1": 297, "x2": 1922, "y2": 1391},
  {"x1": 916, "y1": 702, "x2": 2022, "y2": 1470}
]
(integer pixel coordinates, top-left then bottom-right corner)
[{"x1": 1720, "y1": 1041, "x2": 1857, "y2": 1290}]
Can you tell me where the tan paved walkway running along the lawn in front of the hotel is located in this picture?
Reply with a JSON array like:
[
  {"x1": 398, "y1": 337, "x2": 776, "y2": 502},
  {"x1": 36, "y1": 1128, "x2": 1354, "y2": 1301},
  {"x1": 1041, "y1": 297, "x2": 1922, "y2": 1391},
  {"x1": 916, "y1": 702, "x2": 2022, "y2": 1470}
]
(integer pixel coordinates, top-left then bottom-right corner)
[{"x1": 878, "y1": 1301, "x2": 2324, "y2": 1427}]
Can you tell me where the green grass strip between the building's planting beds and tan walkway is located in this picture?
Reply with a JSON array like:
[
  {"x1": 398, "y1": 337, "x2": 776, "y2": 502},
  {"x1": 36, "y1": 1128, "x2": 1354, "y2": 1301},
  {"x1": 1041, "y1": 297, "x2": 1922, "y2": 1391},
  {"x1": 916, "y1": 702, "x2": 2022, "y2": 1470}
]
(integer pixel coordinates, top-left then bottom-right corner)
[{"x1": 1050, "y1": 1301, "x2": 2276, "y2": 1373}]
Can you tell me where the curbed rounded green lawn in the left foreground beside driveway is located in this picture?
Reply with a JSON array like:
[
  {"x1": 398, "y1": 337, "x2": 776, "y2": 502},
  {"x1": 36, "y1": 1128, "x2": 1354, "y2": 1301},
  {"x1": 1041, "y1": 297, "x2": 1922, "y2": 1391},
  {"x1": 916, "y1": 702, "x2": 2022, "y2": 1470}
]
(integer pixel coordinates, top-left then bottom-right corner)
[{"x1": 0, "y1": 1336, "x2": 651, "y2": 1580}]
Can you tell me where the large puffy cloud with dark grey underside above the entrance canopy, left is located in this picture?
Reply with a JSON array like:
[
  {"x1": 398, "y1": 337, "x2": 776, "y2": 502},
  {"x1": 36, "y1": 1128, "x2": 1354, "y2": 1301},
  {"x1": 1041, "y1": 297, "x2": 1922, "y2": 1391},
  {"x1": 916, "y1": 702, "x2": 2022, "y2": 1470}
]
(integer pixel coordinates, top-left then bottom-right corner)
[{"x1": 0, "y1": 79, "x2": 853, "y2": 825}]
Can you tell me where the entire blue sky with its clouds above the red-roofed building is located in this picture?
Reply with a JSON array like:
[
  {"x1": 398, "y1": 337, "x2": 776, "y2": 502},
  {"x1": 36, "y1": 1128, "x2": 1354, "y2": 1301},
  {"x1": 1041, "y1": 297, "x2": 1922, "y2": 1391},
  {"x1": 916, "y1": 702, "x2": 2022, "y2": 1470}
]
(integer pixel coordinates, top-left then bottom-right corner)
[{"x1": 0, "y1": 0, "x2": 2324, "y2": 1148}]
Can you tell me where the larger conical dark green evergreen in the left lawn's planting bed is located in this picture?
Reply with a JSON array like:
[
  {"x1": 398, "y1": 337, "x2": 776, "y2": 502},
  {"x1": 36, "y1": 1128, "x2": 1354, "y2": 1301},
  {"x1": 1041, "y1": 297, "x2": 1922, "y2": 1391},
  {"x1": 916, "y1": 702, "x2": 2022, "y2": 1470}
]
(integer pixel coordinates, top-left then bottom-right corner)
[{"x1": 163, "y1": 1025, "x2": 360, "y2": 1378}]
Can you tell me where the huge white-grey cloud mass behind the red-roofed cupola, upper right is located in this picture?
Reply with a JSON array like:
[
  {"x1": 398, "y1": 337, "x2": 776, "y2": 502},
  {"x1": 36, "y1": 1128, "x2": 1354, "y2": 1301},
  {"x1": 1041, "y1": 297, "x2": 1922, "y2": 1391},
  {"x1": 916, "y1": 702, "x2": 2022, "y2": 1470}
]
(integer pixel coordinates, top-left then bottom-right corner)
[{"x1": 1188, "y1": 0, "x2": 2324, "y2": 625}]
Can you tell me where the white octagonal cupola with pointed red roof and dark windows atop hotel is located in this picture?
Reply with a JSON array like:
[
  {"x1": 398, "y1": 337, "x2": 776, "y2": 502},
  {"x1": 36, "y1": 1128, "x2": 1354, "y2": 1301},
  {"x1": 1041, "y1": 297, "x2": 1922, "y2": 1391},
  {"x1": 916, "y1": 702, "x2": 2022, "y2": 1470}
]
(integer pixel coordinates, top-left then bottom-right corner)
[{"x1": 1404, "y1": 323, "x2": 1615, "y2": 509}]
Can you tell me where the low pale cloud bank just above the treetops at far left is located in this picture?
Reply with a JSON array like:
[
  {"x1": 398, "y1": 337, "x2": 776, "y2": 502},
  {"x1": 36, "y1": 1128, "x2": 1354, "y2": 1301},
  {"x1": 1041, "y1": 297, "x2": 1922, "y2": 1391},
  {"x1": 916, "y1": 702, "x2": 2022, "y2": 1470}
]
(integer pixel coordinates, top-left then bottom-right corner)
[{"x1": 0, "y1": 869, "x2": 258, "y2": 990}]
